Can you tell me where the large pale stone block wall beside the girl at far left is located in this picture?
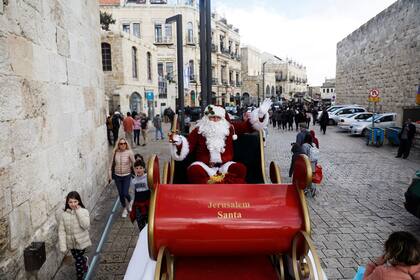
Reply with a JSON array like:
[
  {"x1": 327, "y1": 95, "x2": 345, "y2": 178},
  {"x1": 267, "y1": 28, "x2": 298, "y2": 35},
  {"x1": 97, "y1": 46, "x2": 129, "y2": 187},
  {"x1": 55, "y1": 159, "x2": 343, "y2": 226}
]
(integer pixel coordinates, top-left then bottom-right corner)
[{"x1": 0, "y1": 0, "x2": 108, "y2": 279}]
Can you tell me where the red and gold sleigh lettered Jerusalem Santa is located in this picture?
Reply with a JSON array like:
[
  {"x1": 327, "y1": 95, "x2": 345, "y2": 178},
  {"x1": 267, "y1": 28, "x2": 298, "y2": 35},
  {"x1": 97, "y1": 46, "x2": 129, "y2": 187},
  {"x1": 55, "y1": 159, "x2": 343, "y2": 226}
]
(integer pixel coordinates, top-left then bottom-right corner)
[{"x1": 147, "y1": 129, "x2": 325, "y2": 280}]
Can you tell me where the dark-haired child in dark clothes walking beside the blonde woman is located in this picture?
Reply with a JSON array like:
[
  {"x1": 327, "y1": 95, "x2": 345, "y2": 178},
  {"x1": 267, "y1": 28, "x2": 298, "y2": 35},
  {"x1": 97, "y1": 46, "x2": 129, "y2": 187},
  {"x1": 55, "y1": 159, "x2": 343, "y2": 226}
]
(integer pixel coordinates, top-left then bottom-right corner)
[{"x1": 130, "y1": 160, "x2": 150, "y2": 231}]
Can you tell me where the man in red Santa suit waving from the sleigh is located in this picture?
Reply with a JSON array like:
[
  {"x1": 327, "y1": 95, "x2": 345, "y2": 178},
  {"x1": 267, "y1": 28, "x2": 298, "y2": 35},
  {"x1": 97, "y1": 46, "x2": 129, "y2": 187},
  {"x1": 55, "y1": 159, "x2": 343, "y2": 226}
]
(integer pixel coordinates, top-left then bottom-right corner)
[{"x1": 170, "y1": 99, "x2": 272, "y2": 184}]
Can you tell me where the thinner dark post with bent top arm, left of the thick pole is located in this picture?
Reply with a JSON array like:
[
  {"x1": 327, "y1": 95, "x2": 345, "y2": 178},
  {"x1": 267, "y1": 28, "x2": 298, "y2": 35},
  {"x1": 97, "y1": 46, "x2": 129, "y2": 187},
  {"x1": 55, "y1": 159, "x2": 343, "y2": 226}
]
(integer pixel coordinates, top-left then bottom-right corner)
[{"x1": 165, "y1": 14, "x2": 184, "y2": 131}]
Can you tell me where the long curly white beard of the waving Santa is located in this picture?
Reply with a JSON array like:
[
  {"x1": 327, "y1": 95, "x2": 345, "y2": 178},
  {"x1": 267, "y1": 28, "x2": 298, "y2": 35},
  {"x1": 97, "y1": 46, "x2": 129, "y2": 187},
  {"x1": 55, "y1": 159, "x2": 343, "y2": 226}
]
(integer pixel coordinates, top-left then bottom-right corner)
[{"x1": 197, "y1": 116, "x2": 230, "y2": 163}]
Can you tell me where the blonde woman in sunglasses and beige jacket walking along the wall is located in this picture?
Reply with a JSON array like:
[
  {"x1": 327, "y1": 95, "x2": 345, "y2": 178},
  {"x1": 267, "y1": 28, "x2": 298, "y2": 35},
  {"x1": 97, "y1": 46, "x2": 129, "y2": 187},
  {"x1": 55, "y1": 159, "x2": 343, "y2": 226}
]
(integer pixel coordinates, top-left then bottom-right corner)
[{"x1": 108, "y1": 138, "x2": 134, "y2": 218}]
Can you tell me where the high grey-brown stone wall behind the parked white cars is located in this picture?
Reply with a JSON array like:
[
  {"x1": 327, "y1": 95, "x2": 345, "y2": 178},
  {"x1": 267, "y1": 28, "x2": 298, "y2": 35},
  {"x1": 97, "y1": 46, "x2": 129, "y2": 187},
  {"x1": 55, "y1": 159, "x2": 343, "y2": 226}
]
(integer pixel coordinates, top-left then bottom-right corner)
[{"x1": 336, "y1": 0, "x2": 420, "y2": 121}]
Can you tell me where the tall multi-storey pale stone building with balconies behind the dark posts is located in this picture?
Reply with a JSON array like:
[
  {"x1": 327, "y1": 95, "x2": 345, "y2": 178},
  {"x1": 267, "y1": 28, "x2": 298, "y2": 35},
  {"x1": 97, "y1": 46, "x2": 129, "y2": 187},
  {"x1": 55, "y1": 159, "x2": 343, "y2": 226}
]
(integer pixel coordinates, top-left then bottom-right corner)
[{"x1": 100, "y1": 0, "x2": 241, "y2": 108}]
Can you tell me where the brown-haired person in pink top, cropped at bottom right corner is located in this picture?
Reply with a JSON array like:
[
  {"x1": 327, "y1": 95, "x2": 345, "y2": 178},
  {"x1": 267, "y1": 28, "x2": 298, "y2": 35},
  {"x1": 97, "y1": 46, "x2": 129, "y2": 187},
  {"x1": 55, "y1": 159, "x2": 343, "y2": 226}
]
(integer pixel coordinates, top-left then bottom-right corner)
[{"x1": 363, "y1": 231, "x2": 420, "y2": 280}]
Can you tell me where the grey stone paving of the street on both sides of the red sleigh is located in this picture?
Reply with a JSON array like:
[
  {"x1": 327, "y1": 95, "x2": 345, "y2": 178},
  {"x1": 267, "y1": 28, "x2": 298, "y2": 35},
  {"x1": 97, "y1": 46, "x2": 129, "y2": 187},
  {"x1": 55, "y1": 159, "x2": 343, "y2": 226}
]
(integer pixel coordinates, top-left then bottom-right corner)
[{"x1": 55, "y1": 122, "x2": 420, "y2": 280}]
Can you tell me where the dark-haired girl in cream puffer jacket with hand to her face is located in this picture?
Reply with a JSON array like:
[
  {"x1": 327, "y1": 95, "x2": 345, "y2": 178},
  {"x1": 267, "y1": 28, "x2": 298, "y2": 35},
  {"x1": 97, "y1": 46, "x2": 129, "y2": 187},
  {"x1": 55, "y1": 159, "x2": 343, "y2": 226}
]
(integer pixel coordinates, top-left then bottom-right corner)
[{"x1": 58, "y1": 191, "x2": 92, "y2": 280}]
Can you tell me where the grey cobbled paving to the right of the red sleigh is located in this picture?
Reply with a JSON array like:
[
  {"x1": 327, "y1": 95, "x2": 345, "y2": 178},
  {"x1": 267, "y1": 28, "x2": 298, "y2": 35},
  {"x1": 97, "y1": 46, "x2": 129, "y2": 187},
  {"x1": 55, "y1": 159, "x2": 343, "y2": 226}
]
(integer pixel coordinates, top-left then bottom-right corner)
[{"x1": 265, "y1": 127, "x2": 420, "y2": 279}]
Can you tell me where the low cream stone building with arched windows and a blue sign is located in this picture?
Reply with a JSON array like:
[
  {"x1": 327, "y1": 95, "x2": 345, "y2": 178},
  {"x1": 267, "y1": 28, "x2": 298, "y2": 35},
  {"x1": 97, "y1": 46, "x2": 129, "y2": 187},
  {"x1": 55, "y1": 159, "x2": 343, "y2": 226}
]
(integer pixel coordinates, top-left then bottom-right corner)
[{"x1": 101, "y1": 31, "x2": 171, "y2": 116}]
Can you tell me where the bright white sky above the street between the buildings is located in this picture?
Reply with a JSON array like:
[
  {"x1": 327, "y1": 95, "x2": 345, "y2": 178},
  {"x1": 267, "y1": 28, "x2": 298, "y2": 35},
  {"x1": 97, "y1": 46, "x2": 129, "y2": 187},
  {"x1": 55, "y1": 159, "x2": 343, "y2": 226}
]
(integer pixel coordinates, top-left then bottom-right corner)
[{"x1": 212, "y1": 0, "x2": 395, "y2": 86}]
